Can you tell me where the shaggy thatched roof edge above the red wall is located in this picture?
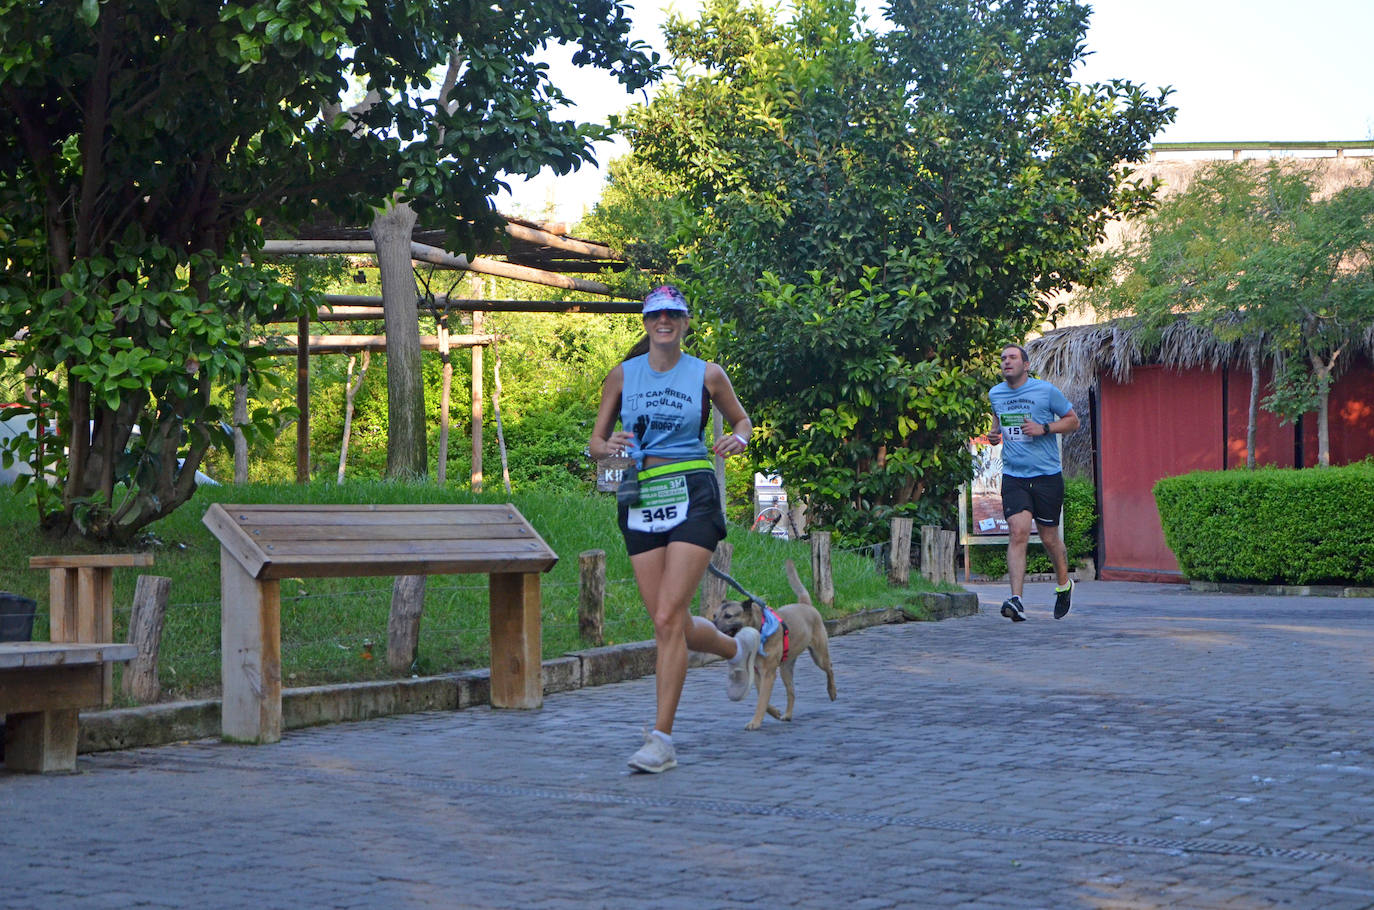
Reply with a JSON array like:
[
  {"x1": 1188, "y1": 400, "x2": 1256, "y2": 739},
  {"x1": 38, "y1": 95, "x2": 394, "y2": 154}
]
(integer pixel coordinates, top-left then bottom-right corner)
[{"x1": 1025, "y1": 316, "x2": 1374, "y2": 400}]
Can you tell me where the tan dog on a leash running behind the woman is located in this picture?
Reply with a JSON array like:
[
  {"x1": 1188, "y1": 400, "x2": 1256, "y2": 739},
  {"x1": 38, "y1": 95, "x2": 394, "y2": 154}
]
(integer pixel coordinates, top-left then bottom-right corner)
[{"x1": 714, "y1": 559, "x2": 835, "y2": 730}]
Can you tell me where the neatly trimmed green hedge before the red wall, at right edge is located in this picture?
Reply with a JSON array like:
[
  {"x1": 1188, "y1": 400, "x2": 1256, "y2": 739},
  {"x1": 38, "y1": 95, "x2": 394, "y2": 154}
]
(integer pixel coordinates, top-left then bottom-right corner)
[{"x1": 1154, "y1": 460, "x2": 1374, "y2": 586}]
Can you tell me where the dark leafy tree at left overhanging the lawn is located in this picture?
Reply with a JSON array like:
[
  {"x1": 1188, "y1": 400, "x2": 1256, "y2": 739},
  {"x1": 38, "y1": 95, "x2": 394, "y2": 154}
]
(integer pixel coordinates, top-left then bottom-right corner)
[{"x1": 0, "y1": 0, "x2": 657, "y2": 540}]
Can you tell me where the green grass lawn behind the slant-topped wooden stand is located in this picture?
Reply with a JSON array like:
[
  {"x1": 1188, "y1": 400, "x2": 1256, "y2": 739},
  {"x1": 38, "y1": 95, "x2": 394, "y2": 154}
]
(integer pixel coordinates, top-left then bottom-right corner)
[{"x1": 0, "y1": 482, "x2": 934, "y2": 700}]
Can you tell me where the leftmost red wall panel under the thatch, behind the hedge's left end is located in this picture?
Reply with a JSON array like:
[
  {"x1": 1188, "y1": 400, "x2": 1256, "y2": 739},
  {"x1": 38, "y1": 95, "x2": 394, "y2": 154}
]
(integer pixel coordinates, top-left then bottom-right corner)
[{"x1": 1096, "y1": 367, "x2": 1225, "y2": 581}]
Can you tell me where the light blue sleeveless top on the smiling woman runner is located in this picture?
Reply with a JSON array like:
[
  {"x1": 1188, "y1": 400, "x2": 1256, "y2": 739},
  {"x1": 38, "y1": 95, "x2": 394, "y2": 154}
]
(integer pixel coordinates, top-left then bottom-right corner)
[{"x1": 620, "y1": 353, "x2": 708, "y2": 467}]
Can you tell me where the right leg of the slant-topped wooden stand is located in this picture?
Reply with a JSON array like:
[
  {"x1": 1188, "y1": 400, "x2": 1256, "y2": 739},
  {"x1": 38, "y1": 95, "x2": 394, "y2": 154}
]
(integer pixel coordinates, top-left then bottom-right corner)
[{"x1": 491, "y1": 572, "x2": 544, "y2": 708}]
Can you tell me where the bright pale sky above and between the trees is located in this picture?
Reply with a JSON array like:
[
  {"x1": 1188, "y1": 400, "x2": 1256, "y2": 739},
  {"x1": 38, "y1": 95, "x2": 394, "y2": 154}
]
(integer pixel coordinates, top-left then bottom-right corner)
[{"x1": 497, "y1": 0, "x2": 1374, "y2": 221}]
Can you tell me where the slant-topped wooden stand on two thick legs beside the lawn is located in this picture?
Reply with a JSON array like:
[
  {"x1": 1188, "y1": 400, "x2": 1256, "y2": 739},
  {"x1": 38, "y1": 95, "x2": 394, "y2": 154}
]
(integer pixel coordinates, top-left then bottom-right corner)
[{"x1": 205, "y1": 503, "x2": 558, "y2": 742}]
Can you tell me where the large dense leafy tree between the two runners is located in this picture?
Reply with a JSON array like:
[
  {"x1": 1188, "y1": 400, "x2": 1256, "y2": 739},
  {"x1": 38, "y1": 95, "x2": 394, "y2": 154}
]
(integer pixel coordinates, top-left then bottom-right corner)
[{"x1": 599, "y1": 0, "x2": 1173, "y2": 537}]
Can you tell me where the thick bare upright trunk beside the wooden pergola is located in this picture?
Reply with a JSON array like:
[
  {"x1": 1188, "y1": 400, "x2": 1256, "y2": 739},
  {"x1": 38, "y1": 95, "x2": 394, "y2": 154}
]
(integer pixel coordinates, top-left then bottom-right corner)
[{"x1": 371, "y1": 205, "x2": 429, "y2": 480}]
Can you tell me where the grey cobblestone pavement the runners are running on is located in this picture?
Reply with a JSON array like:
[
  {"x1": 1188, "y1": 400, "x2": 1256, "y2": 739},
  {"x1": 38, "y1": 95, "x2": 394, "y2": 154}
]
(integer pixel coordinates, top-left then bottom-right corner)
[{"x1": 0, "y1": 583, "x2": 1374, "y2": 910}]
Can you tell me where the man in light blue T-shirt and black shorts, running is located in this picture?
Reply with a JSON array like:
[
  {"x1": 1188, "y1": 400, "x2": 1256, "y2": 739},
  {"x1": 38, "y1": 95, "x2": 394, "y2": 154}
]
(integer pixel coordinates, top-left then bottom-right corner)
[{"x1": 988, "y1": 345, "x2": 1079, "y2": 623}]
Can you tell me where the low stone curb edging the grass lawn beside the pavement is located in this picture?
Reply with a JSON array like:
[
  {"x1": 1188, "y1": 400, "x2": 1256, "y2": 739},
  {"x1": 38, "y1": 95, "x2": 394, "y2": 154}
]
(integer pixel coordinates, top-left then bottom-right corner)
[{"x1": 77, "y1": 591, "x2": 978, "y2": 753}]
